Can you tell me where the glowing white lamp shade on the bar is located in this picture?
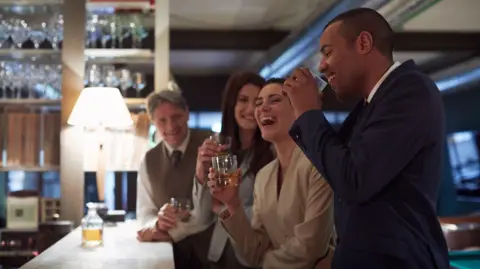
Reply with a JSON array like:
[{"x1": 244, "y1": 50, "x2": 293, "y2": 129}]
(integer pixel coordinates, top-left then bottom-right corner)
[{"x1": 67, "y1": 87, "x2": 133, "y2": 128}]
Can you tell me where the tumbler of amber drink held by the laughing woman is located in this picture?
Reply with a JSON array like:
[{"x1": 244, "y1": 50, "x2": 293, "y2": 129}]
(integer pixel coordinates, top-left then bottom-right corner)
[{"x1": 212, "y1": 154, "x2": 240, "y2": 187}]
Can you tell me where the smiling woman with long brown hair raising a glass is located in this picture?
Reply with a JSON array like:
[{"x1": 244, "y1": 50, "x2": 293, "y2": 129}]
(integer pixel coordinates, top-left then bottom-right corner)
[{"x1": 158, "y1": 72, "x2": 274, "y2": 269}]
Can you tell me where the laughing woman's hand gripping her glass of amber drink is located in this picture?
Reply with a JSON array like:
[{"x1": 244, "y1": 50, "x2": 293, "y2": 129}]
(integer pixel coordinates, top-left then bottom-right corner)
[{"x1": 207, "y1": 168, "x2": 241, "y2": 210}]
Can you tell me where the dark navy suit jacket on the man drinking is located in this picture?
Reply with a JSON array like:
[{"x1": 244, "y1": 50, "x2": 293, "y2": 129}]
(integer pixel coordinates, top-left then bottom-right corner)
[{"x1": 290, "y1": 61, "x2": 448, "y2": 269}]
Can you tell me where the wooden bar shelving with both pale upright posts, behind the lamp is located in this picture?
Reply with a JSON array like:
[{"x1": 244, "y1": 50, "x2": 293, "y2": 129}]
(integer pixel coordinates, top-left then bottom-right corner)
[{"x1": 0, "y1": 0, "x2": 172, "y2": 228}]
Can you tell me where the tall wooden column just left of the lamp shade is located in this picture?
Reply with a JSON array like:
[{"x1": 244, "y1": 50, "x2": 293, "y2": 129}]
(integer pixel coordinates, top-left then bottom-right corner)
[{"x1": 60, "y1": 0, "x2": 86, "y2": 225}]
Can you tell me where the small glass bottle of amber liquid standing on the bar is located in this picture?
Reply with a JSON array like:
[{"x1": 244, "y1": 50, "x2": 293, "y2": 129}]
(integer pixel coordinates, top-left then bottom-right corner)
[{"x1": 82, "y1": 203, "x2": 103, "y2": 247}]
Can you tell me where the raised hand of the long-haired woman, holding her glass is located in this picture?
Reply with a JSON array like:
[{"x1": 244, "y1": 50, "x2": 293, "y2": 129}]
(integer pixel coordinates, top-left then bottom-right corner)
[{"x1": 195, "y1": 139, "x2": 221, "y2": 184}]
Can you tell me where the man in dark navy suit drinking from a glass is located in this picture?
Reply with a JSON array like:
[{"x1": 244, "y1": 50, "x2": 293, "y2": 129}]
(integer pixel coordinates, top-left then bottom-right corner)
[{"x1": 284, "y1": 8, "x2": 448, "y2": 269}]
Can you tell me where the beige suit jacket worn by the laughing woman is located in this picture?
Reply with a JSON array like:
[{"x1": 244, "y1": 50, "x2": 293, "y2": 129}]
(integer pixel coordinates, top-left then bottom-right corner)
[{"x1": 222, "y1": 147, "x2": 333, "y2": 269}]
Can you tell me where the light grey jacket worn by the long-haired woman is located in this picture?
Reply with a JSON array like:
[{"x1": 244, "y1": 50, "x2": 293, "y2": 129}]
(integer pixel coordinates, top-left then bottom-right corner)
[{"x1": 168, "y1": 151, "x2": 255, "y2": 266}]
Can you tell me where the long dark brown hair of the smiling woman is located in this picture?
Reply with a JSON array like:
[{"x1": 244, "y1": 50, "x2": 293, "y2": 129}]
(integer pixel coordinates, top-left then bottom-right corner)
[{"x1": 221, "y1": 72, "x2": 274, "y2": 176}]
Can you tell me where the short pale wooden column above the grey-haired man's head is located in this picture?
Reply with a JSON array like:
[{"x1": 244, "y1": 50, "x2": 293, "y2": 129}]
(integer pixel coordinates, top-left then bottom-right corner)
[{"x1": 155, "y1": 0, "x2": 170, "y2": 92}]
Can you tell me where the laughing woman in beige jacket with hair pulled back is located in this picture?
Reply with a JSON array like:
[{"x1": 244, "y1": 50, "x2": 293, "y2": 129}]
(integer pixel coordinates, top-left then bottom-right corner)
[{"x1": 208, "y1": 79, "x2": 334, "y2": 269}]
